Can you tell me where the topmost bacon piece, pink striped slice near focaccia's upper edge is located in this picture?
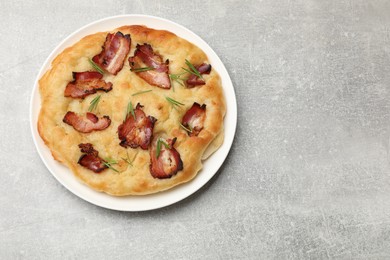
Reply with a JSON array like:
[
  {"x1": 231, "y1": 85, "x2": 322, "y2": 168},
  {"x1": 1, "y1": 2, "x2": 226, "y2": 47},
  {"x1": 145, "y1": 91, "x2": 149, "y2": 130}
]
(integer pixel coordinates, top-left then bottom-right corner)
[{"x1": 92, "y1": 32, "x2": 131, "y2": 75}]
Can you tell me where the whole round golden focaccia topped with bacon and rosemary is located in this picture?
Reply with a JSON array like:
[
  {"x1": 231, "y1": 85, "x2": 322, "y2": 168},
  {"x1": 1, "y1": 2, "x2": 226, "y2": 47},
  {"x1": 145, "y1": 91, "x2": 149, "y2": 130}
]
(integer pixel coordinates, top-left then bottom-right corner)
[{"x1": 38, "y1": 25, "x2": 226, "y2": 196}]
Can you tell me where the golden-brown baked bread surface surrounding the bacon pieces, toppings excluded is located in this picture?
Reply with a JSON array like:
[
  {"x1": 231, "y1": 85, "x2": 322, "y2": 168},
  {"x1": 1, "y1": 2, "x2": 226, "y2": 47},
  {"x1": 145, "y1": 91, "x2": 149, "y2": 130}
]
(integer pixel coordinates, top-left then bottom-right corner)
[{"x1": 38, "y1": 26, "x2": 226, "y2": 196}]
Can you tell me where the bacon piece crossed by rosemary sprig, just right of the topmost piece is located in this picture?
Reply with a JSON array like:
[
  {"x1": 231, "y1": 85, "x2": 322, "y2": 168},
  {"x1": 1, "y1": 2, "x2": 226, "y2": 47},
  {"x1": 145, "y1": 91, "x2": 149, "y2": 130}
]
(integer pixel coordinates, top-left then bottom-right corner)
[{"x1": 129, "y1": 43, "x2": 171, "y2": 89}]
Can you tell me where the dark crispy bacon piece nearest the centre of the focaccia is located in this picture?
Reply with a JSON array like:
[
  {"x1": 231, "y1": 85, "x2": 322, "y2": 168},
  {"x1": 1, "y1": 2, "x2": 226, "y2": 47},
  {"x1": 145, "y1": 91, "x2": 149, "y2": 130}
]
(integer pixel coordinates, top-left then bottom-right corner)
[{"x1": 118, "y1": 103, "x2": 157, "y2": 150}]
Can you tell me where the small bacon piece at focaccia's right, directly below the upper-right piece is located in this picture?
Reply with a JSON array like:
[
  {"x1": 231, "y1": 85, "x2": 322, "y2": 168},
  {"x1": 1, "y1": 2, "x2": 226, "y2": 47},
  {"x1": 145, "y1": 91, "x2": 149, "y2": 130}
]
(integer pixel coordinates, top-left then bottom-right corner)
[{"x1": 181, "y1": 102, "x2": 206, "y2": 136}]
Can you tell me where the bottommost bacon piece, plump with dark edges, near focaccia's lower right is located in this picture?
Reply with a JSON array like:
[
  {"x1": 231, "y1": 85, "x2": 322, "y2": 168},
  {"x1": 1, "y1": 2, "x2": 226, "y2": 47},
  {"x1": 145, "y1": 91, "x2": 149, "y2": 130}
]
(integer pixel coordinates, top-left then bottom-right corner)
[{"x1": 149, "y1": 138, "x2": 183, "y2": 179}]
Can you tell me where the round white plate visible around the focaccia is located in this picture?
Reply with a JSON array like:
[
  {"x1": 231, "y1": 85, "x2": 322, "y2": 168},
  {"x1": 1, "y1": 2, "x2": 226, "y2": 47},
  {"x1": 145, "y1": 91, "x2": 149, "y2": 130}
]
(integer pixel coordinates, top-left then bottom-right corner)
[{"x1": 30, "y1": 15, "x2": 237, "y2": 211}]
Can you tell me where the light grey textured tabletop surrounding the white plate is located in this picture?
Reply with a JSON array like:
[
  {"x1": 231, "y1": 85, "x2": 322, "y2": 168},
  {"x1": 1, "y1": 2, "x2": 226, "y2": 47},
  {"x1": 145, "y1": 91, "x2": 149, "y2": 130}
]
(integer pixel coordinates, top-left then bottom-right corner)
[{"x1": 0, "y1": 0, "x2": 390, "y2": 259}]
